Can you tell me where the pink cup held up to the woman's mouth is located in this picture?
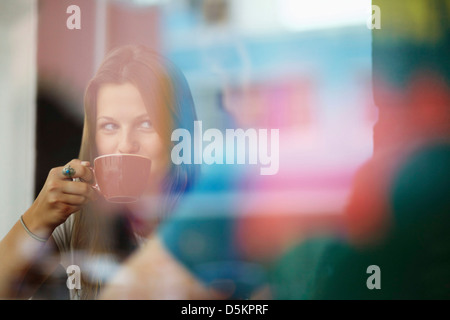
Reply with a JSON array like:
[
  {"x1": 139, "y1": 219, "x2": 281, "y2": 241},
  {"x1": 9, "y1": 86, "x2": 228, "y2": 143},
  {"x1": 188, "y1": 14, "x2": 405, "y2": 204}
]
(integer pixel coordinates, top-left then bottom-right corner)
[{"x1": 93, "y1": 154, "x2": 151, "y2": 203}]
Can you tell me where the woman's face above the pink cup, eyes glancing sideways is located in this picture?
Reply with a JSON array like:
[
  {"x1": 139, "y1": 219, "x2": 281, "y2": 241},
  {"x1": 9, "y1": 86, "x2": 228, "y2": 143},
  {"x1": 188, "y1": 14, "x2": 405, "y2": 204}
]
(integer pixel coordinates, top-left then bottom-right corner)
[{"x1": 95, "y1": 83, "x2": 170, "y2": 192}]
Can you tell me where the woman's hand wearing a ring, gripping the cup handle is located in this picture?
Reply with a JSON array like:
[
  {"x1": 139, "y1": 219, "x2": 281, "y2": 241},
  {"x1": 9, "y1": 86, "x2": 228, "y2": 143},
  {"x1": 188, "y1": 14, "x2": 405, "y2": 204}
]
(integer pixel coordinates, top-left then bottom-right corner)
[{"x1": 23, "y1": 159, "x2": 97, "y2": 237}]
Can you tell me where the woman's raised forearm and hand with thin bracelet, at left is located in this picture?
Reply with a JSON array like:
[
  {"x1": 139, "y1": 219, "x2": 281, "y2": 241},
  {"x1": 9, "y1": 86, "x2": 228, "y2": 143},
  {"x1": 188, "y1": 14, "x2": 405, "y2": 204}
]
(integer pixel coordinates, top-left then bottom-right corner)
[{"x1": 0, "y1": 160, "x2": 95, "y2": 298}]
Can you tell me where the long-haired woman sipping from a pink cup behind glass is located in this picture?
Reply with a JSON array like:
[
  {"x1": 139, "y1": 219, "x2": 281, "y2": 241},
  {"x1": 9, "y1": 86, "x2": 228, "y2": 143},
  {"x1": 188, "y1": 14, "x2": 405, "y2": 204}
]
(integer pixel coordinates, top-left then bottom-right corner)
[{"x1": 0, "y1": 46, "x2": 196, "y2": 299}]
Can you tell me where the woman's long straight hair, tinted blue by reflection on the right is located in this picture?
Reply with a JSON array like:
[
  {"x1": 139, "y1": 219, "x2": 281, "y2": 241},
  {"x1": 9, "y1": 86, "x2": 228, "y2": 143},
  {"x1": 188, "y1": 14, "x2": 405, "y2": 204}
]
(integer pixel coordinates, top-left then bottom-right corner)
[{"x1": 71, "y1": 45, "x2": 198, "y2": 299}]
